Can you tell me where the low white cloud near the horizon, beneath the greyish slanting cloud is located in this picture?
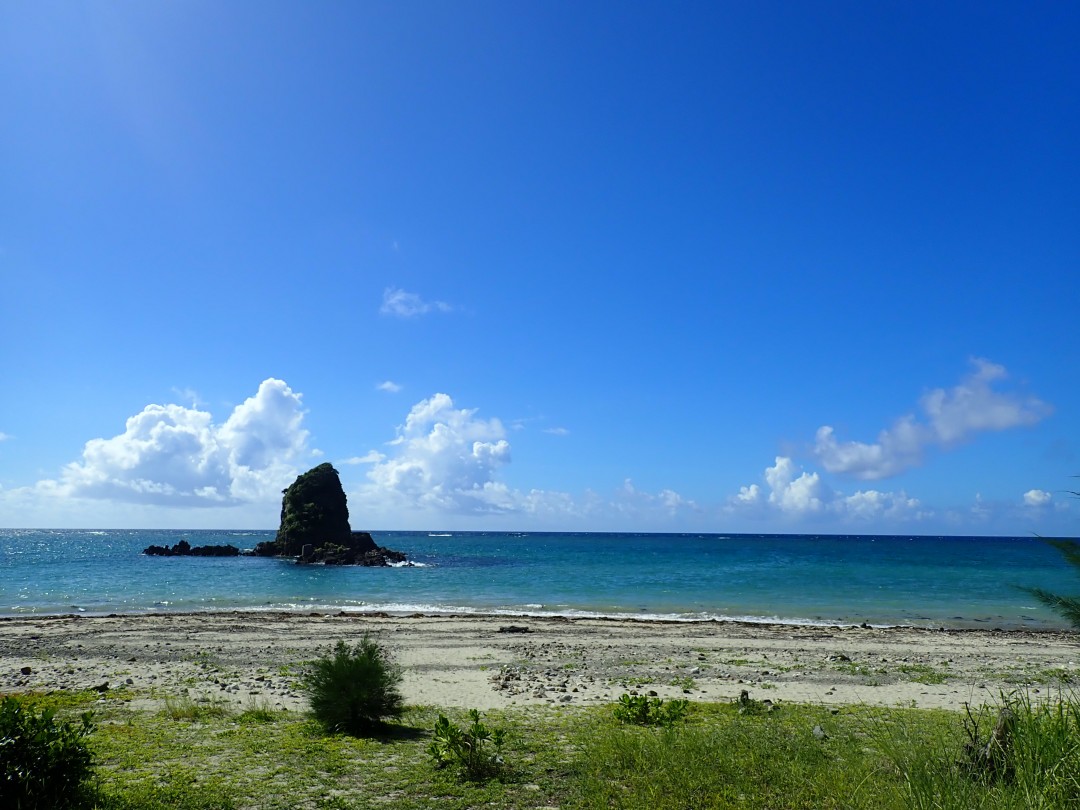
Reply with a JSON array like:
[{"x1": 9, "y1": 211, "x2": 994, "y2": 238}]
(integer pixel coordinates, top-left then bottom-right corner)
[{"x1": 727, "y1": 456, "x2": 923, "y2": 521}]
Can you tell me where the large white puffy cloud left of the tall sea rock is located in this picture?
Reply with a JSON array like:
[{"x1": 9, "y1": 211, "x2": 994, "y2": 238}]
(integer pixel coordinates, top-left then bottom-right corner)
[{"x1": 50, "y1": 378, "x2": 308, "y2": 507}]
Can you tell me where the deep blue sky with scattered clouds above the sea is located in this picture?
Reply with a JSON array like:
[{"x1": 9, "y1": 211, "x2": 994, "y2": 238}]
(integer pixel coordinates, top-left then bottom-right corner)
[{"x1": 0, "y1": 0, "x2": 1080, "y2": 535}]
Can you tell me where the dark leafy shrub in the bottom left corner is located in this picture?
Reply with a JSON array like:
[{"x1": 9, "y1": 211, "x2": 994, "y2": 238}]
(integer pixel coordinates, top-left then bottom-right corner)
[{"x1": 0, "y1": 697, "x2": 94, "y2": 810}]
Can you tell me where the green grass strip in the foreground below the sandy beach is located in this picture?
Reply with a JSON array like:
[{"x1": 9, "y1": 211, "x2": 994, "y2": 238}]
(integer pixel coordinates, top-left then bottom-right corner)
[{"x1": 12, "y1": 692, "x2": 1080, "y2": 810}]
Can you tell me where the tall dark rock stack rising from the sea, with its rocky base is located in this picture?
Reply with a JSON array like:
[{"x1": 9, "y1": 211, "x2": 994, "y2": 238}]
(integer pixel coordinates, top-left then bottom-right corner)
[{"x1": 253, "y1": 463, "x2": 405, "y2": 566}]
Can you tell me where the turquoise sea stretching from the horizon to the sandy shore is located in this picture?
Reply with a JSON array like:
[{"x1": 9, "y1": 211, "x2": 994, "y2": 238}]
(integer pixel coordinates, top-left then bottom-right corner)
[{"x1": 0, "y1": 529, "x2": 1080, "y2": 629}]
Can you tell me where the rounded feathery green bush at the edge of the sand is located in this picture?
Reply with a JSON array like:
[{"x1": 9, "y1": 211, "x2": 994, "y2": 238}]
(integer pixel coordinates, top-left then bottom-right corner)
[{"x1": 303, "y1": 635, "x2": 405, "y2": 735}]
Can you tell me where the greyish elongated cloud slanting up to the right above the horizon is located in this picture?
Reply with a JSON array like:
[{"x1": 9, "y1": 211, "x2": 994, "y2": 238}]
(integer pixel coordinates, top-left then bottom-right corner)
[{"x1": 814, "y1": 359, "x2": 1051, "y2": 481}]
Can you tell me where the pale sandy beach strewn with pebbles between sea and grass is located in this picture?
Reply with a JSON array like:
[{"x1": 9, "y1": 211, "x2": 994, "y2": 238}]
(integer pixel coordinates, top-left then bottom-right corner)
[{"x1": 0, "y1": 612, "x2": 1080, "y2": 710}]
